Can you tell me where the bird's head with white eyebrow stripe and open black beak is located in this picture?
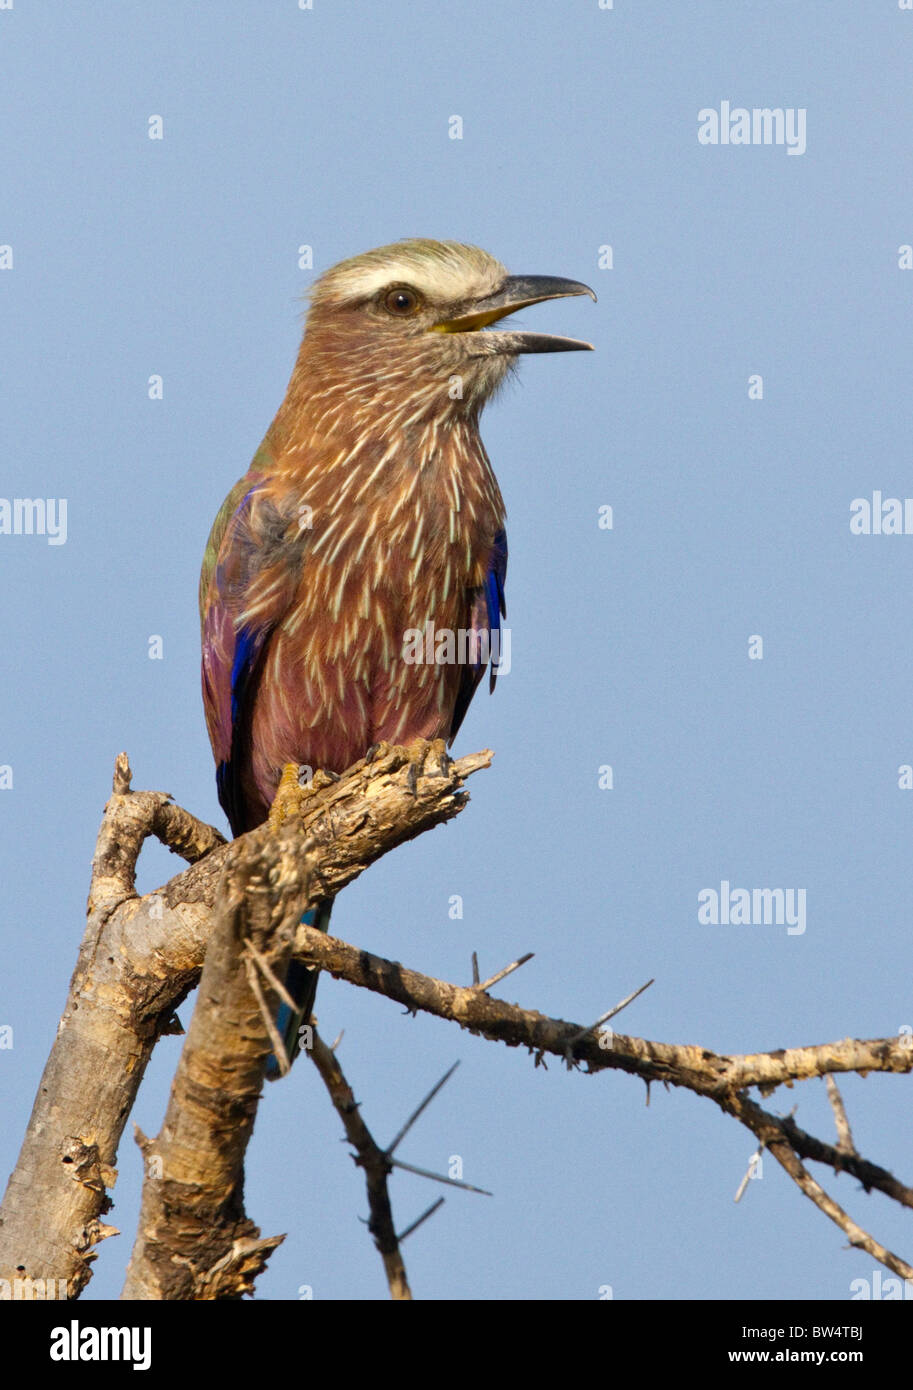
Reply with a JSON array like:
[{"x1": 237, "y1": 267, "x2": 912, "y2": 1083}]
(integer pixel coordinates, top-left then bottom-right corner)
[{"x1": 299, "y1": 239, "x2": 596, "y2": 420}]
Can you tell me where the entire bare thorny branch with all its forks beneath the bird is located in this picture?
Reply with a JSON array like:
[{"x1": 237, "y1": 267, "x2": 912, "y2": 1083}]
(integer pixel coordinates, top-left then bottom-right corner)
[{"x1": 0, "y1": 744, "x2": 913, "y2": 1298}]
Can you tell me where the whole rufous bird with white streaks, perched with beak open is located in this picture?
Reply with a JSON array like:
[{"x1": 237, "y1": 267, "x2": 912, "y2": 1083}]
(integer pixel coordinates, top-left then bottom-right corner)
[{"x1": 199, "y1": 238, "x2": 596, "y2": 1080}]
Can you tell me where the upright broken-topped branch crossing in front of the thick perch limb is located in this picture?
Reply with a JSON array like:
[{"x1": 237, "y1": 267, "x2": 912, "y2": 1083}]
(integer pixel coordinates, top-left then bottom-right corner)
[{"x1": 124, "y1": 834, "x2": 309, "y2": 1300}]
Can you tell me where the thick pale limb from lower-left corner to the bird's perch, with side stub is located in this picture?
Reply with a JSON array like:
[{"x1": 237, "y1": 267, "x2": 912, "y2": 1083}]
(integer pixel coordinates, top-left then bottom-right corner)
[{"x1": 0, "y1": 741, "x2": 491, "y2": 1297}]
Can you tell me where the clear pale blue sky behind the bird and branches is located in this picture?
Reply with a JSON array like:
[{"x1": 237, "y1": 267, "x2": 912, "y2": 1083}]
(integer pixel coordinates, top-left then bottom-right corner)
[{"x1": 0, "y1": 0, "x2": 913, "y2": 1301}]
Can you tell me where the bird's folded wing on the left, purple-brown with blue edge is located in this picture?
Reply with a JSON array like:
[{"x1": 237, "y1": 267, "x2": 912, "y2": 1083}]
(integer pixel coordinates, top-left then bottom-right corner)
[{"x1": 200, "y1": 470, "x2": 307, "y2": 835}]
